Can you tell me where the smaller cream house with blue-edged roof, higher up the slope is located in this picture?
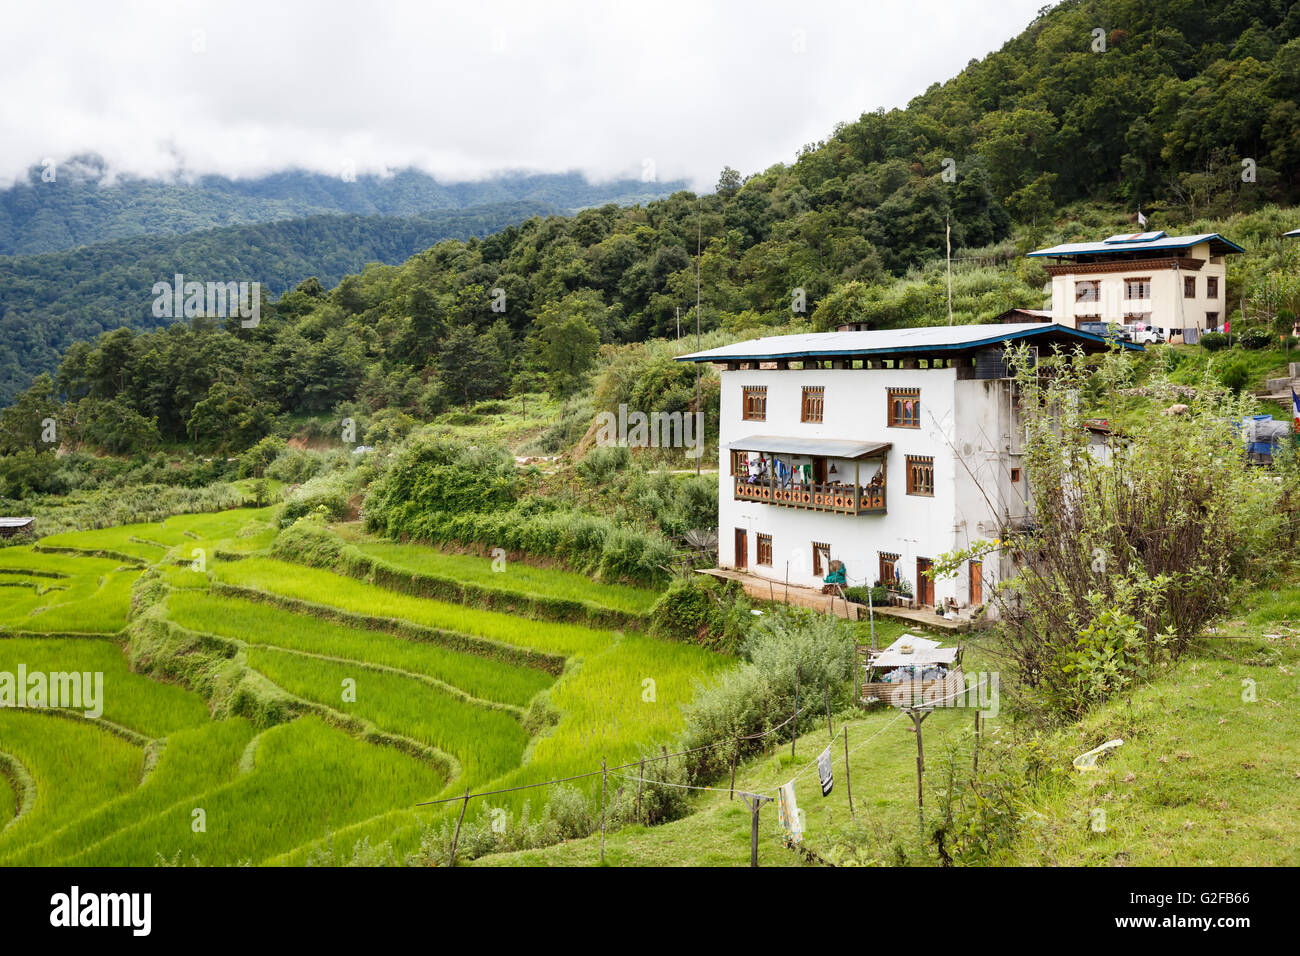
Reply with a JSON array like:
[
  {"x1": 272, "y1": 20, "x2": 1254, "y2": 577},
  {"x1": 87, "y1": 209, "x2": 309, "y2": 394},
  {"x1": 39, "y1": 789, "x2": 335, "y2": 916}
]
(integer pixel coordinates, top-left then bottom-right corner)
[{"x1": 1030, "y1": 233, "x2": 1245, "y2": 342}]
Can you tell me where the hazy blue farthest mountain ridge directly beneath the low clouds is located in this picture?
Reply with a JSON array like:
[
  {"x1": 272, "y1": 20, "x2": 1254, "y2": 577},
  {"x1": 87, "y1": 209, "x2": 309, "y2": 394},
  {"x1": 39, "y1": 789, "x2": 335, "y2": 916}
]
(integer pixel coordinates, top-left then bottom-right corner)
[{"x1": 0, "y1": 155, "x2": 685, "y2": 255}]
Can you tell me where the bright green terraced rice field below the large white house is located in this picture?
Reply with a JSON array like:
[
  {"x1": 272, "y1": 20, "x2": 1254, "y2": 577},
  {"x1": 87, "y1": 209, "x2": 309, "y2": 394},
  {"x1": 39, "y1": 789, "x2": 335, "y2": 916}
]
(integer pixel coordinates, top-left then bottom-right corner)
[{"x1": 0, "y1": 509, "x2": 728, "y2": 865}]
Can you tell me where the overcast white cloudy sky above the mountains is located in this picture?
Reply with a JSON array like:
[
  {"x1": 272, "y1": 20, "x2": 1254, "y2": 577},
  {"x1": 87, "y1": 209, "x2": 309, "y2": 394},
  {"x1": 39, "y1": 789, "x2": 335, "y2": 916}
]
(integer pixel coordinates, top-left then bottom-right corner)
[{"x1": 0, "y1": 0, "x2": 1045, "y2": 187}]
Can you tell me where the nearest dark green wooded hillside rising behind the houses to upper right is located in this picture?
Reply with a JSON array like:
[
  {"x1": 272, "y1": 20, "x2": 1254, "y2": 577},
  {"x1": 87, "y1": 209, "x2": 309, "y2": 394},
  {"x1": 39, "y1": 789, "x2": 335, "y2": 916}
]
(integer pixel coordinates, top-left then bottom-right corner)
[{"x1": 0, "y1": 0, "x2": 1300, "y2": 463}]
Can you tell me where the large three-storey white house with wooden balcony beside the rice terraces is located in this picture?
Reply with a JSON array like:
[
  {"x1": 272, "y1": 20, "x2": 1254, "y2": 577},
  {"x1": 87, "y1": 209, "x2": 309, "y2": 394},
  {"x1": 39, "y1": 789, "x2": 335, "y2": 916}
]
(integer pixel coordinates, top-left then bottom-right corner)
[{"x1": 680, "y1": 323, "x2": 1132, "y2": 616}]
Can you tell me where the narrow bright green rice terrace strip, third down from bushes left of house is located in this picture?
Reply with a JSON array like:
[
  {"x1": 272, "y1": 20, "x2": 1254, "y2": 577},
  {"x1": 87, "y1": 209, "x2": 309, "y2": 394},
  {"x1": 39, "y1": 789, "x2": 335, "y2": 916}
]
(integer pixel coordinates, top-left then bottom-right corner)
[{"x1": 168, "y1": 592, "x2": 553, "y2": 706}]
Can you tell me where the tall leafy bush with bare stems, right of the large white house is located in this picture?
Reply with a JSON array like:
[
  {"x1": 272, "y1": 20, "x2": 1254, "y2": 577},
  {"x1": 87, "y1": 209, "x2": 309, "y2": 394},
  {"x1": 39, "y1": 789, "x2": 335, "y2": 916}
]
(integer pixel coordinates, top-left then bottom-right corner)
[{"x1": 971, "y1": 350, "x2": 1286, "y2": 719}]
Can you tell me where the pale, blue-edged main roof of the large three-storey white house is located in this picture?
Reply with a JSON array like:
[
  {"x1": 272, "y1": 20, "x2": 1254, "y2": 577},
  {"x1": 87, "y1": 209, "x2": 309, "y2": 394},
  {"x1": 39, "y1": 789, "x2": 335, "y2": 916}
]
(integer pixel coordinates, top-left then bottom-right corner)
[{"x1": 677, "y1": 323, "x2": 1143, "y2": 362}]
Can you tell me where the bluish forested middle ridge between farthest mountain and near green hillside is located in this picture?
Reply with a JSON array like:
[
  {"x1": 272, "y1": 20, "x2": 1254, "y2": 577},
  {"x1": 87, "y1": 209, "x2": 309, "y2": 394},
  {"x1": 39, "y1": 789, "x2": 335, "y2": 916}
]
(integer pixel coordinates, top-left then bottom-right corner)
[{"x1": 0, "y1": 200, "x2": 558, "y2": 406}]
